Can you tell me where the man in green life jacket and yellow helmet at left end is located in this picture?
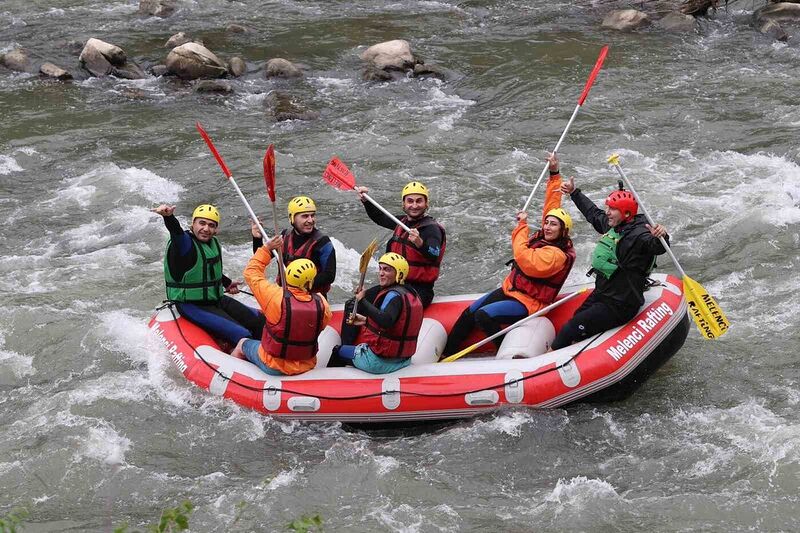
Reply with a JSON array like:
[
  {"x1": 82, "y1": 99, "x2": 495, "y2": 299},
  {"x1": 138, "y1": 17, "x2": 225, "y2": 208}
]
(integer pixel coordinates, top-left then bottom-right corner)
[{"x1": 152, "y1": 204, "x2": 264, "y2": 344}]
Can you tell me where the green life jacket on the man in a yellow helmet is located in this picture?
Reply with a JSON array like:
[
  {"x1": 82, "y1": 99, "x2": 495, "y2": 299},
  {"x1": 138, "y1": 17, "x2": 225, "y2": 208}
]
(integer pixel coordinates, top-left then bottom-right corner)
[{"x1": 164, "y1": 230, "x2": 225, "y2": 304}]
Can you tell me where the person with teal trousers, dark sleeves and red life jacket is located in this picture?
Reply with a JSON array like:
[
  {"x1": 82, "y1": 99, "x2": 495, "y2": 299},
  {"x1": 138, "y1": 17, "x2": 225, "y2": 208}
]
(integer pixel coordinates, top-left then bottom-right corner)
[{"x1": 328, "y1": 252, "x2": 422, "y2": 374}]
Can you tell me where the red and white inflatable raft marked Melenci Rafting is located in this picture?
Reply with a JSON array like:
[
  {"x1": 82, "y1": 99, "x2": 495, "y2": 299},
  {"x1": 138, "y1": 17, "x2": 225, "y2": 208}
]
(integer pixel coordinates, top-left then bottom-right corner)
[{"x1": 150, "y1": 274, "x2": 689, "y2": 424}]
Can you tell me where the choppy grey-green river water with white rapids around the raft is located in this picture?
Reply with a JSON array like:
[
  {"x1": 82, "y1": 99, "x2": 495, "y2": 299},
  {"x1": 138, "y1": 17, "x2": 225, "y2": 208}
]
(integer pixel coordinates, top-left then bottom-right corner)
[{"x1": 0, "y1": 0, "x2": 800, "y2": 531}]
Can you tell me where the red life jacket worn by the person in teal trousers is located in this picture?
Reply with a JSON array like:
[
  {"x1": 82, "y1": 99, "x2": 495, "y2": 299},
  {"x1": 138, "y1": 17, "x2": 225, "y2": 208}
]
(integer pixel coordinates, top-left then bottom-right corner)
[{"x1": 362, "y1": 285, "x2": 422, "y2": 359}]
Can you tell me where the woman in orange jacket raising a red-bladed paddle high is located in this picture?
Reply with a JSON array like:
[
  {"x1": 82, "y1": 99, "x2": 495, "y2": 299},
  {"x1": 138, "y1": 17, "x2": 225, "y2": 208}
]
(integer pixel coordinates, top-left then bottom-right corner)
[{"x1": 442, "y1": 154, "x2": 575, "y2": 356}]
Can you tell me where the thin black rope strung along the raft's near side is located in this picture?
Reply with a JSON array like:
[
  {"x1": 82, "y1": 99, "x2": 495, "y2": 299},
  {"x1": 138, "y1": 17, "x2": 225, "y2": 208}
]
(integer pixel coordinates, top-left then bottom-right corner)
[{"x1": 166, "y1": 302, "x2": 605, "y2": 400}]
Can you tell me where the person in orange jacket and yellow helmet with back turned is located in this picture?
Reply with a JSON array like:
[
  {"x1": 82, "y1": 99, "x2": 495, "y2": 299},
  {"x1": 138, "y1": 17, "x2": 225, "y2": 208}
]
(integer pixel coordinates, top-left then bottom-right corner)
[{"x1": 231, "y1": 235, "x2": 331, "y2": 376}]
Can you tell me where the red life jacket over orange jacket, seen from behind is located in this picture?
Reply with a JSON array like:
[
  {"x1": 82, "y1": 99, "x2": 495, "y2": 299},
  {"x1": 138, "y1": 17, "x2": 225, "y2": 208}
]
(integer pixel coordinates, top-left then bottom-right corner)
[{"x1": 261, "y1": 291, "x2": 325, "y2": 361}]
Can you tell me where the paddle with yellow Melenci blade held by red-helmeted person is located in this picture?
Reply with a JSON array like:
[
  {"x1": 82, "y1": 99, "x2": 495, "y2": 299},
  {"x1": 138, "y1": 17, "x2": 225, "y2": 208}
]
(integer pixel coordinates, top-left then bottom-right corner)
[{"x1": 608, "y1": 154, "x2": 730, "y2": 339}]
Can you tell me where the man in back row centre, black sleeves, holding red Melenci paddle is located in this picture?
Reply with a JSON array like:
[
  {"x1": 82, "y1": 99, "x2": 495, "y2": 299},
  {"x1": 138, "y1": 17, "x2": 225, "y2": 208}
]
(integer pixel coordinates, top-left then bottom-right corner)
[{"x1": 356, "y1": 181, "x2": 447, "y2": 307}]
